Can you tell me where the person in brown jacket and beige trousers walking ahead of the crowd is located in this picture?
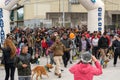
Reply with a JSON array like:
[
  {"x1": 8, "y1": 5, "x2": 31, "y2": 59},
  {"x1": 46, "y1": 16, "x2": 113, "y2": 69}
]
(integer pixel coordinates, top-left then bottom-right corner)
[{"x1": 49, "y1": 36, "x2": 70, "y2": 78}]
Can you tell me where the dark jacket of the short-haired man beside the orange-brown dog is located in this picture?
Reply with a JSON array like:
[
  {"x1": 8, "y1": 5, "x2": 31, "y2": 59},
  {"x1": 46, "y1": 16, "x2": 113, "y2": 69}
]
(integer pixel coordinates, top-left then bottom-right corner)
[{"x1": 16, "y1": 53, "x2": 37, "y2": 76}]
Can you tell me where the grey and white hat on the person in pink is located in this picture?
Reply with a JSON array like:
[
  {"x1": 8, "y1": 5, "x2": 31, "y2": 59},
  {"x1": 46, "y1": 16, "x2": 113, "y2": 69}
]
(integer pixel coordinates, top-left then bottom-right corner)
[{"x1": 81, "y1": 52, "x2": 92, "y2": 64}]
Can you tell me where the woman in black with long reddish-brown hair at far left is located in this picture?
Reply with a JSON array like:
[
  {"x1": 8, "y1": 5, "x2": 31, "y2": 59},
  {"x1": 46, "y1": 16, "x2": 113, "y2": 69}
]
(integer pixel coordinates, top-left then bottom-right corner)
[{"x1": 0, "y1": 39, "x2": 16, "y2": 80}]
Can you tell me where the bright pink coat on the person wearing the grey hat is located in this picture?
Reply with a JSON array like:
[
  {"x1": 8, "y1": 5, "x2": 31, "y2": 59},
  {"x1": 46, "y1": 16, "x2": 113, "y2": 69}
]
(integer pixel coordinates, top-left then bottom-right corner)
[{"x1": 69, "y1": 61, "x2": 102, "y2": 80}]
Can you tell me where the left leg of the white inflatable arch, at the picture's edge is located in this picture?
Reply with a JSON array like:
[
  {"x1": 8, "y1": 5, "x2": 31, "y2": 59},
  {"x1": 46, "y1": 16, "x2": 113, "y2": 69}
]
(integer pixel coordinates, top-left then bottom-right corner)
[{"x1": 0, "y1": 0, "x2": 19, "y2": 43}]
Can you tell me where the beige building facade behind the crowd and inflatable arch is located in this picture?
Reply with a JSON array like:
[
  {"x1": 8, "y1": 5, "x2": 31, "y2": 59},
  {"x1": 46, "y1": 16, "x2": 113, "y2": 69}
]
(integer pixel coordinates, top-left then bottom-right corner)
[{"x1": 12, "y1": 0, "x2": 120, "y2": 27}]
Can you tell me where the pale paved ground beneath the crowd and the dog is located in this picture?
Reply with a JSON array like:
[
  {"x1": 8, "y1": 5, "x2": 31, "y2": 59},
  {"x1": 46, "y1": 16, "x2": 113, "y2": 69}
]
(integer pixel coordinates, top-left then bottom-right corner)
[{"x1": 0, "y1": 58, "x2": 120, "y2": 80}]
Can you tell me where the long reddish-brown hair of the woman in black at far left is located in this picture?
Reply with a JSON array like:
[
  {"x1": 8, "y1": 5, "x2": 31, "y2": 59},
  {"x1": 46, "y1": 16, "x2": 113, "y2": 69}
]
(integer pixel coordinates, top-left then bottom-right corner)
[{"x1": 4, "y1": 39, "x2": 16, "y2": 58}]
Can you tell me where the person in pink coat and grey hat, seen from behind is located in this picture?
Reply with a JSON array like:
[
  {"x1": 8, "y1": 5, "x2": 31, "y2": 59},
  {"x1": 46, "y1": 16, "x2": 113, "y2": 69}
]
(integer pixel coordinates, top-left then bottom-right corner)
[{"x1": 69, "y1": 52, "x2": 102, "y2": 80}]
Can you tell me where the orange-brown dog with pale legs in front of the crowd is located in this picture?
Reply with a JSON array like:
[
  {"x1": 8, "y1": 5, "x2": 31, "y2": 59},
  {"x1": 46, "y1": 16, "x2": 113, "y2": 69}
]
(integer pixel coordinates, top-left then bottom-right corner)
[{"x1": 32, "y1": 64, "x2": 53, "y2": 80}]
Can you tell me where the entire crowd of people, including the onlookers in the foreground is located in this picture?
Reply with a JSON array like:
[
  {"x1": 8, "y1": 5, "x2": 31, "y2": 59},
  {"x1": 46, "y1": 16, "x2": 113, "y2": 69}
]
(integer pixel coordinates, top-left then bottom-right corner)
[{"x1": 0, "y1": 27, "x2": 120, "y2": 80}]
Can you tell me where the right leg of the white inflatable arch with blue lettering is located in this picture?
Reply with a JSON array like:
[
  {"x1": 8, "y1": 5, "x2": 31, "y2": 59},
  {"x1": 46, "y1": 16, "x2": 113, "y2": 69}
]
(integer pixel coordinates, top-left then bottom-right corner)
[{"x1": 79, "y1": 0, "x2": 105, "y2": 33}]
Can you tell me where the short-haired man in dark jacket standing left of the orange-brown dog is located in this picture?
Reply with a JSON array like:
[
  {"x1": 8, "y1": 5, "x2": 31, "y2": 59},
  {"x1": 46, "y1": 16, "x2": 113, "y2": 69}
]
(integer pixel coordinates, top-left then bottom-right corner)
[{"x1": 16, "y1": 45, "x2": 38, "y2": 80}]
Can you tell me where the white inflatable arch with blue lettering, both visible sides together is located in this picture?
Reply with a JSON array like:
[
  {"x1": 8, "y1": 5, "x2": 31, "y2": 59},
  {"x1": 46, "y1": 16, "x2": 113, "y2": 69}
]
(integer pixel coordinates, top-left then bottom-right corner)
[{"x1": 0, "y1": 0, "x2": 104, "y2": 43}]
